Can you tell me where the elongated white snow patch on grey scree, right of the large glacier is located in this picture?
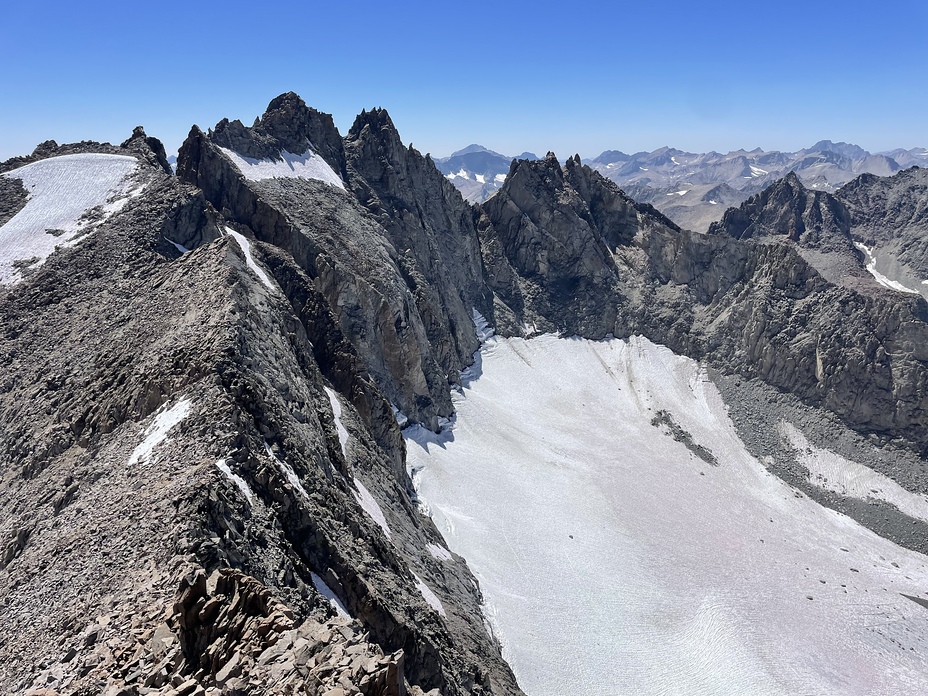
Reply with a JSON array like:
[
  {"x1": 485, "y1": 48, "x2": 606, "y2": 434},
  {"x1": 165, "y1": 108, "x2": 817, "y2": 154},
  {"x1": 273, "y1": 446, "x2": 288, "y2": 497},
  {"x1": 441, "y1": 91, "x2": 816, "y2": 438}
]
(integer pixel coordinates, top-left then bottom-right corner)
[{"x1": 779, "y1": 421, "x2": 928, "y2": 522}]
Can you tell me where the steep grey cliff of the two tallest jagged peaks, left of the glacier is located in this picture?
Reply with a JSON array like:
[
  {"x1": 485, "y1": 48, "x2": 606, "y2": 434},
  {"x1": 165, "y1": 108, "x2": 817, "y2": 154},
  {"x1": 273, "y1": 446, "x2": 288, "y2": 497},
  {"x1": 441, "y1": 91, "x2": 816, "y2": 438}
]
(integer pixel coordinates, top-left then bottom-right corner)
[{"x1": 177, "y1": 95, "x2": 489, "y2": 429}]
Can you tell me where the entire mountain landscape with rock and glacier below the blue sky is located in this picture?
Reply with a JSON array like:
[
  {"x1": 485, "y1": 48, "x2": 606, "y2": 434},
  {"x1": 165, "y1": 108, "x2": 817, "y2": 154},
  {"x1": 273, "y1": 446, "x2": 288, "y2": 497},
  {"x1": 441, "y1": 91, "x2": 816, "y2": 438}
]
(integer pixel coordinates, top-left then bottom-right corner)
[{"x1": 0, "y1": 92, "x2": 928, "y2": 696}]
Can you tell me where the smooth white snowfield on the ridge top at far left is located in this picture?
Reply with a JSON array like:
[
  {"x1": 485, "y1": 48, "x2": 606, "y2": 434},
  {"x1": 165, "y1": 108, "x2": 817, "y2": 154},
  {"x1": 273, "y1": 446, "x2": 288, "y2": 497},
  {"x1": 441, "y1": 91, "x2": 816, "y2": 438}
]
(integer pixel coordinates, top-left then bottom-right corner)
[{"x1": 0, "y1": 153, "x2": 141, "y2": 285}]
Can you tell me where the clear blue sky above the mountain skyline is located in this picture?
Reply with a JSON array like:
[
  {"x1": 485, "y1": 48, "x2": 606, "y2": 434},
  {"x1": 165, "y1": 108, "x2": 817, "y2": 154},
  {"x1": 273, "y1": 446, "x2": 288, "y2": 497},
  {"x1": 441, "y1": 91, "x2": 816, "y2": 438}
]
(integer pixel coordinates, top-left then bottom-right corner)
[{"x1": 0, "y1": 0, "x2": 928, "y2": 160}]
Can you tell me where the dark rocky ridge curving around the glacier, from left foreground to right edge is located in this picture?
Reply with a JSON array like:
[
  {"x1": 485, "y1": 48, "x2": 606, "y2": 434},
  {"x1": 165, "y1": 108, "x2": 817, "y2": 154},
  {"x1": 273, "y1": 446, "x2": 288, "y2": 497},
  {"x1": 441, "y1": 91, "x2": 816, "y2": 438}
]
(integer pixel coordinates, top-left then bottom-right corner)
[{"x1": 0, "y1": 93, "x2": 928, "y2": 696}]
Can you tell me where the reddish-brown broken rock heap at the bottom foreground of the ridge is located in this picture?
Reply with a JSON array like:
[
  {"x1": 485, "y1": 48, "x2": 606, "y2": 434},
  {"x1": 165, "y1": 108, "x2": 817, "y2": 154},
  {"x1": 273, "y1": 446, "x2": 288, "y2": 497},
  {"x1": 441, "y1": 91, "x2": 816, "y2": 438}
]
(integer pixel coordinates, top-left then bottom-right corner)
[{"x1": 26, "y1": 567, "x2": 416, "y2": 696}]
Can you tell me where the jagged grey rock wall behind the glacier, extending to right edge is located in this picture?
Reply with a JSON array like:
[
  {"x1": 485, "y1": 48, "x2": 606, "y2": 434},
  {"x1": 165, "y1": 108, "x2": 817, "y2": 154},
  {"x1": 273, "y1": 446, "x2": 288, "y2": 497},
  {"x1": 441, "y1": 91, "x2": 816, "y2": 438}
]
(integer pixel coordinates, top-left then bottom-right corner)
[{"x1": 479, "y1": 157, "x2": 928, "y2": 448}]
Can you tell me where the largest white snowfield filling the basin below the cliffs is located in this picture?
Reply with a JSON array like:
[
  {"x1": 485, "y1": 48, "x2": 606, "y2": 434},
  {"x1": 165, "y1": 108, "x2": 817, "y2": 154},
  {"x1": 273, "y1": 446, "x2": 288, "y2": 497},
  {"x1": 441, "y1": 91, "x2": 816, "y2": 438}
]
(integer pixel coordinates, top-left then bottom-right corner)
[{"x1": 404, "y1": 335, "x2": 928, "y2": 696}]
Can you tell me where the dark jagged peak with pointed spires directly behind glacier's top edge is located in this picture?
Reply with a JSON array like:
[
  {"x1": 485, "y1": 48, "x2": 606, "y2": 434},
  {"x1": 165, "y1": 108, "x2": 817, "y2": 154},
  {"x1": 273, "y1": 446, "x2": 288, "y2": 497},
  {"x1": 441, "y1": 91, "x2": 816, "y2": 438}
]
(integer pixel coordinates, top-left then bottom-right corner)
[{"x1": 478, "y1": 153, "x2": 664, "y2": 337}]
